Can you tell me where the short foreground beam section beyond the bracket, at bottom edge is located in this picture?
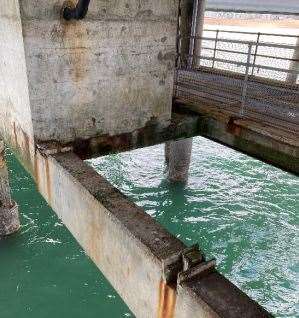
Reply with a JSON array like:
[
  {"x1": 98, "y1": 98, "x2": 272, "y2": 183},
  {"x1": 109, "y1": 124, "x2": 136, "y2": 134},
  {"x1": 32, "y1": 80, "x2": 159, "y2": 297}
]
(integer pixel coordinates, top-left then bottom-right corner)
[{"x1": 176, "y1": 271, "x2": 273, "y2": 318}]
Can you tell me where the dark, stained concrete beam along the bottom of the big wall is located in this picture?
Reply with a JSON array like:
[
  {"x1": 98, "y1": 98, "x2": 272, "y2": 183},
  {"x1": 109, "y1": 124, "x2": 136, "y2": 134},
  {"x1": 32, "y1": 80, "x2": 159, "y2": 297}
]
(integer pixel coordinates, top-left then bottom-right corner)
[{"x1": 38, "y1": 111, "x2": 199, "y2": 159}]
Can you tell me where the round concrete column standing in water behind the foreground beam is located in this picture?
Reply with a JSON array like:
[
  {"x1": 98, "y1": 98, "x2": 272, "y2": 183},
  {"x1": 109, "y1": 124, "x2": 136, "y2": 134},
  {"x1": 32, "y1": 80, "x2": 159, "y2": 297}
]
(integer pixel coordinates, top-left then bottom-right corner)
[{"x1": 165, "y1": 138, "x2": 192, "y2": 183}]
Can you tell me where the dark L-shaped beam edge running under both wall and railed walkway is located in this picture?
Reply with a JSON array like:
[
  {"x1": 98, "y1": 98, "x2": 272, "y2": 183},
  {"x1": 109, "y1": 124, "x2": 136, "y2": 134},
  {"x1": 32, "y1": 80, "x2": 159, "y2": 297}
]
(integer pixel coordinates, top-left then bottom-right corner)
[{"x1": 39, "y1": 107, "x2": 299, "y2": 175}]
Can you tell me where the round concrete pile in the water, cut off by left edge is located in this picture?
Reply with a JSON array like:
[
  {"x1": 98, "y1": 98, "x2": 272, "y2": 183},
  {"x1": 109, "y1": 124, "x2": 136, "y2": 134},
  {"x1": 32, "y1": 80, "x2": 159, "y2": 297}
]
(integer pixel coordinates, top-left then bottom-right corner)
[{"x1": 0, "y1": 141, "x2": 20, "y2": 237}]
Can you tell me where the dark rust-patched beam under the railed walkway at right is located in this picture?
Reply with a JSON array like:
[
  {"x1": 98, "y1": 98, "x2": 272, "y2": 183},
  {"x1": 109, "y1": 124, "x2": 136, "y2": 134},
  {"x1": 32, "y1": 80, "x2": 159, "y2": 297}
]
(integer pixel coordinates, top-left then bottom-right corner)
[{"x1": 176, "y1": 103, "x2": 299, "y2": 175}]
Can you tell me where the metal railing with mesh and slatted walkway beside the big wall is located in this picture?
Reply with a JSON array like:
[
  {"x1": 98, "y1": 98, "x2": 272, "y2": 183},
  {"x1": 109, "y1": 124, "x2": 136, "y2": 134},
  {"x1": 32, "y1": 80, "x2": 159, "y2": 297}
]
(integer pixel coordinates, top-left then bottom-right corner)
[{"x1": 175, "y1": 30, "x2": 299, "y2": 123}]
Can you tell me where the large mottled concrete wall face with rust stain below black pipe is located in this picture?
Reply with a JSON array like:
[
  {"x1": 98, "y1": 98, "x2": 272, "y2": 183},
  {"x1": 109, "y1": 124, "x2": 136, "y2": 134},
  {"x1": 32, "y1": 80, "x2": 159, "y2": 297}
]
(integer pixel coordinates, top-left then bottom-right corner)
[{"x1": 19, "y1": 0, "x2": 178, "y2": 142}]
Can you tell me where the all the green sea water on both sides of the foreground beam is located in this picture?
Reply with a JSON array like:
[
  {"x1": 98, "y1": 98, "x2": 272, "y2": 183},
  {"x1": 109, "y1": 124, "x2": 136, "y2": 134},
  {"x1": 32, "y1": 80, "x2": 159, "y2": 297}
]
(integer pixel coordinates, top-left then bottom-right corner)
[{"x1": 0, "y1": 138, "x2": 299, "y2": 318}]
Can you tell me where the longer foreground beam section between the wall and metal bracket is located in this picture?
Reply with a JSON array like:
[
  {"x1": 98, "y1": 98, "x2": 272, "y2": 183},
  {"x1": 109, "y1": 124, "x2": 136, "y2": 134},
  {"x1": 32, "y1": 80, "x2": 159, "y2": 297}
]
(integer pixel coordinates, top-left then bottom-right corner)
[{"x1": 38, "y1": 150, "x2": 183, "y2": 317}]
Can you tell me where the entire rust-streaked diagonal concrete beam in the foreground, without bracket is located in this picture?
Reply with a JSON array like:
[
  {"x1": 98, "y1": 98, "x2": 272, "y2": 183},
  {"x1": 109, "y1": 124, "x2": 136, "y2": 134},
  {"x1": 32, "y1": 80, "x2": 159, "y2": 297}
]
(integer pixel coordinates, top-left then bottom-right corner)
[{"x1": 36, "y1": 153, "x2": 270, "y2": 318}]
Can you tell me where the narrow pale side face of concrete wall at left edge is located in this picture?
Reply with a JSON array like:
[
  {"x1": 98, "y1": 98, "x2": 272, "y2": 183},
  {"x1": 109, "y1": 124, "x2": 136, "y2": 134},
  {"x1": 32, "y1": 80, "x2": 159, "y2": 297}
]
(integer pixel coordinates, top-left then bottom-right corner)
[{"x1": 0, "y1": 0, "x2": 33, "y2": 163}]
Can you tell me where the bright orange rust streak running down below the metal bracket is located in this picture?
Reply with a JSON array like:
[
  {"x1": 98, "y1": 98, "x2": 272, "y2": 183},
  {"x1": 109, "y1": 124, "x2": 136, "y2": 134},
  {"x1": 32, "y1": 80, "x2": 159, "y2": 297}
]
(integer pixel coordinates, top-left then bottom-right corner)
[{"x1": 158, "y1": 280, "x2": 176, "y2": 318}]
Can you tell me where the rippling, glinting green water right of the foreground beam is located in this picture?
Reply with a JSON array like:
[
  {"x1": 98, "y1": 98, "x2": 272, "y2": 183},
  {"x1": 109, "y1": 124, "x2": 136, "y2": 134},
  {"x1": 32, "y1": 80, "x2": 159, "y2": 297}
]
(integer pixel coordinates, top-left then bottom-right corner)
[{"x1": 91, "y1": 138, "x2": 299, "y2": 317}]
